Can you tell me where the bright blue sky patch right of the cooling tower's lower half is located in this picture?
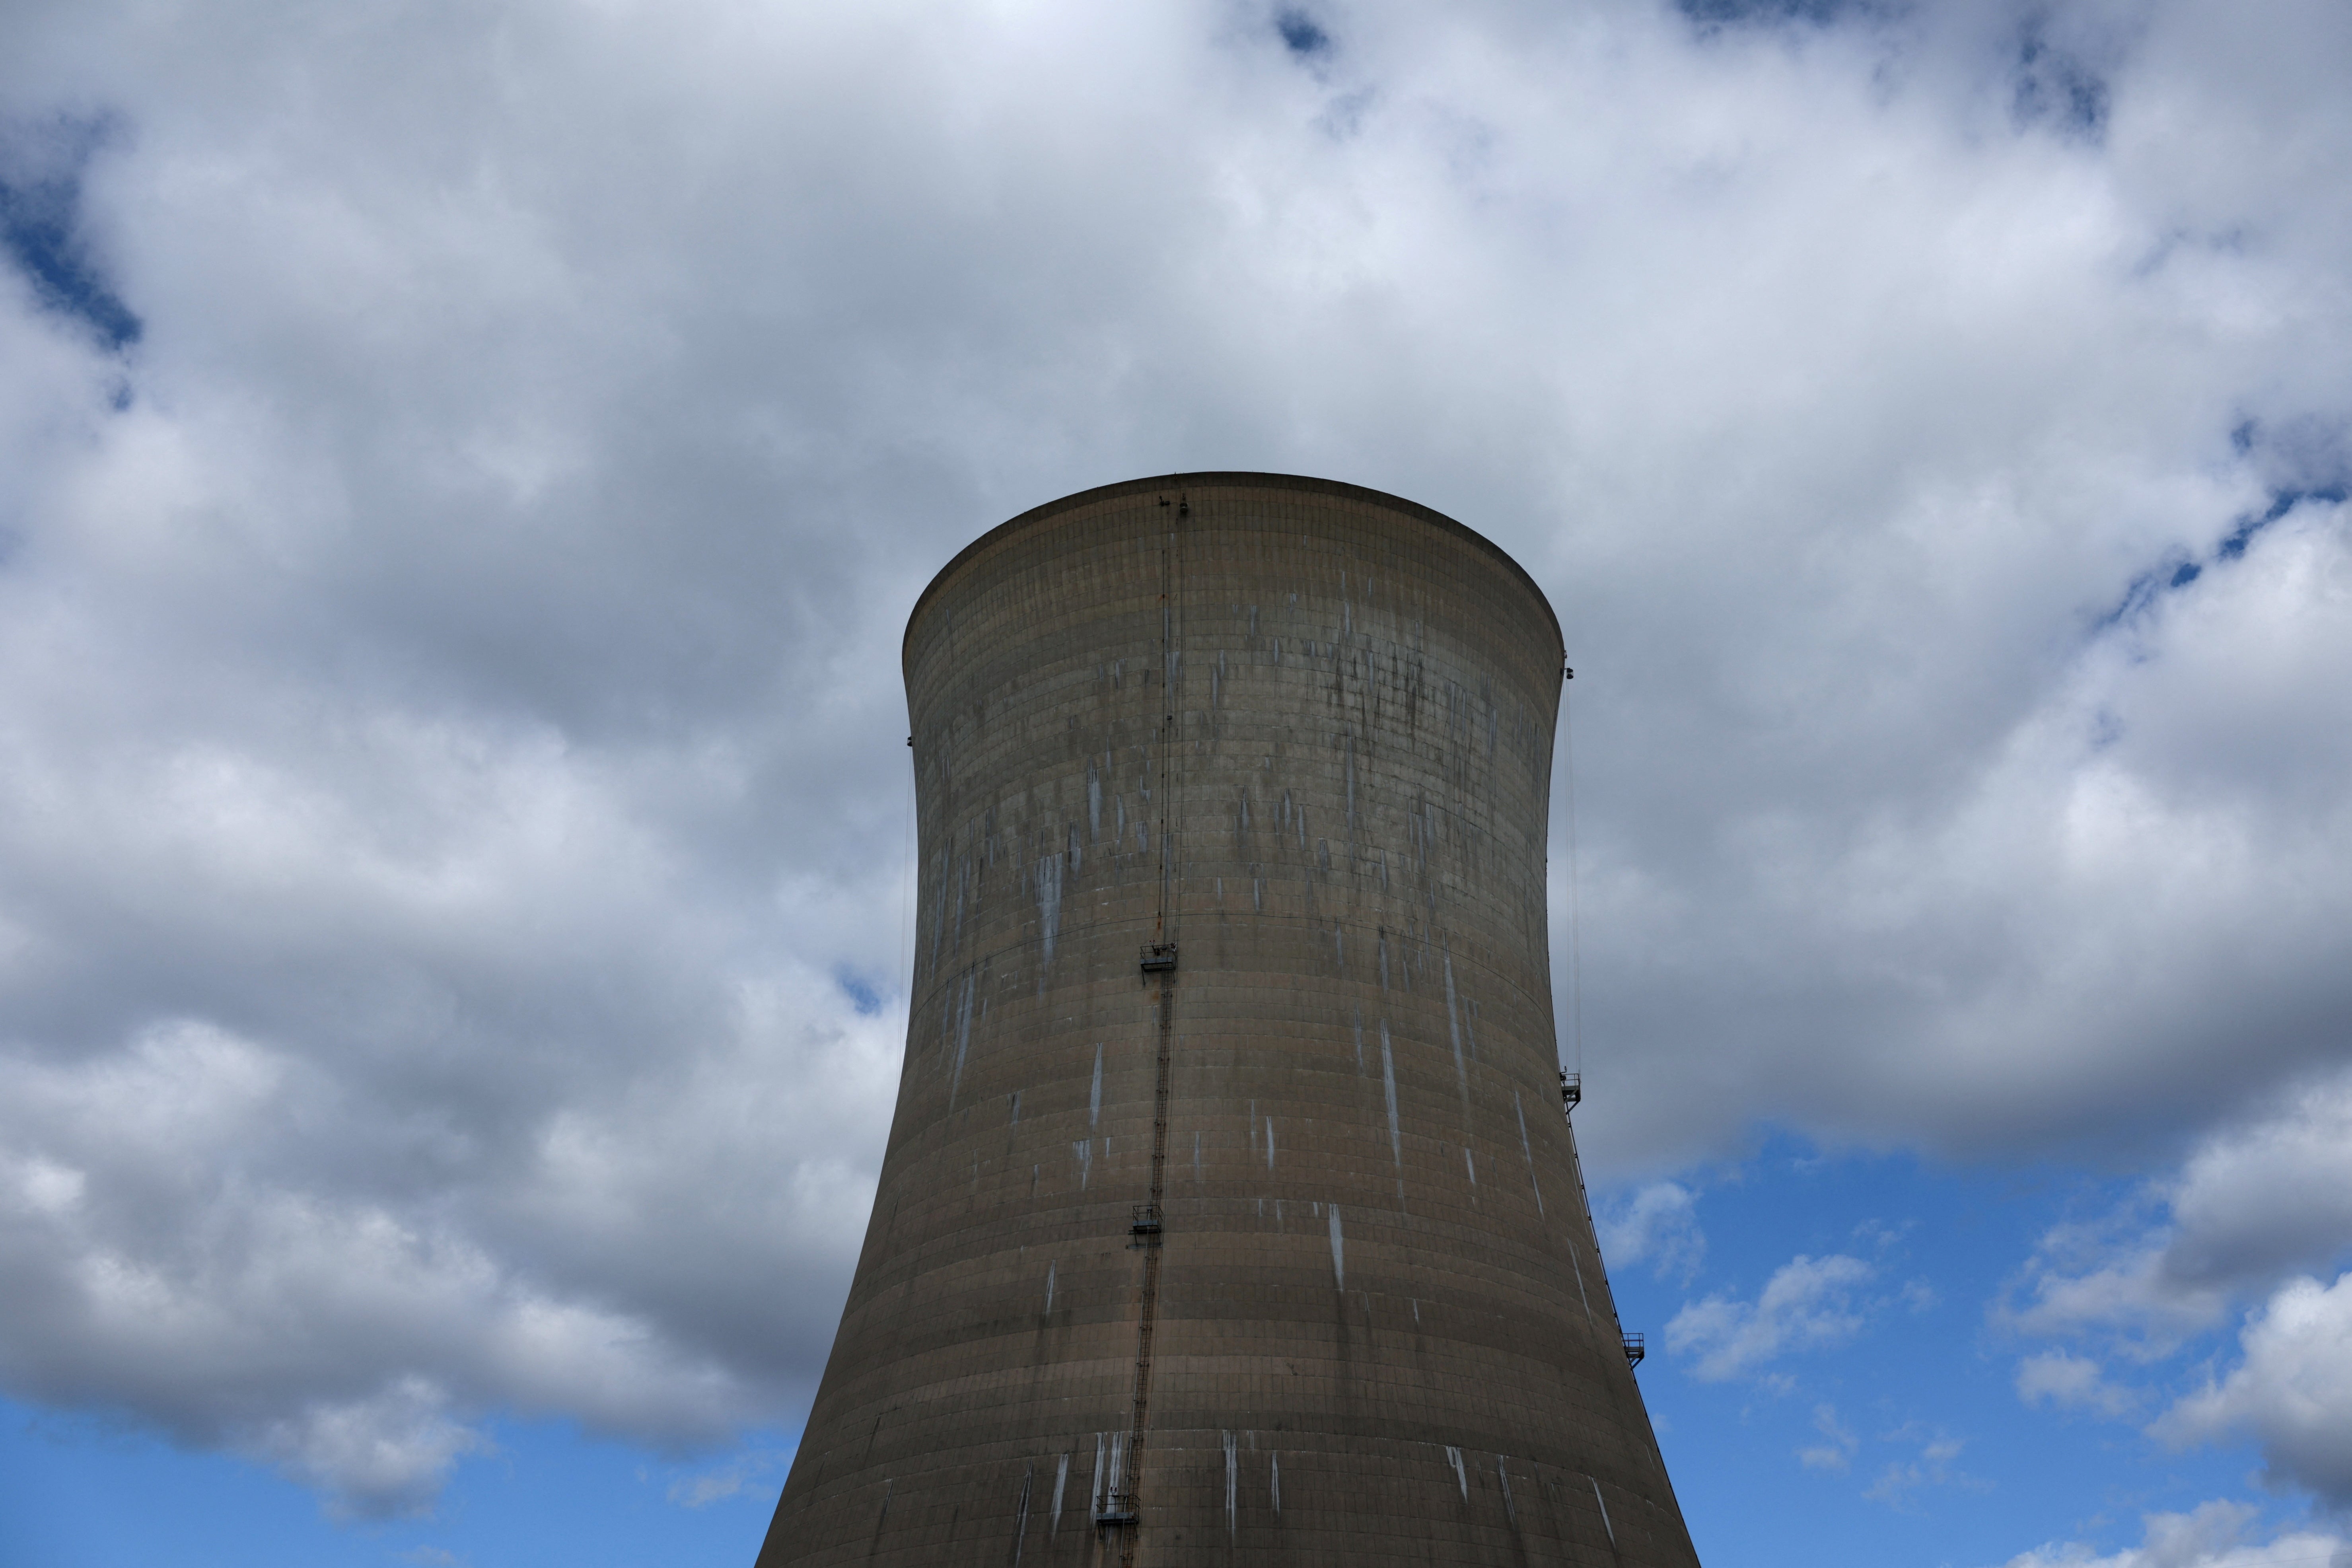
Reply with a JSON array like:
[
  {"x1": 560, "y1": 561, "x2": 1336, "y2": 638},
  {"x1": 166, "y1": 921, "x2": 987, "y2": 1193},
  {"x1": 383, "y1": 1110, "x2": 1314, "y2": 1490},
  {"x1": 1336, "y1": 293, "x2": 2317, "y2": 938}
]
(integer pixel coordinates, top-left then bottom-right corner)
[{"x1": 1613, "y1": 1142, "x2": 2305, "y2": 1563}]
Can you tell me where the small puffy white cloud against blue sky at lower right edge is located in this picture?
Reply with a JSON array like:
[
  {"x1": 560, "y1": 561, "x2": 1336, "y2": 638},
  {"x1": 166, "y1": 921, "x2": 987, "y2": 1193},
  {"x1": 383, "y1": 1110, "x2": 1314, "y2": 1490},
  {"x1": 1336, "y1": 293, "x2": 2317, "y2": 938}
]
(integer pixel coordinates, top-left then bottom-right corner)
[{"x1": 2152, "y1": 1274, "x2": 2352, "y2": 1507}]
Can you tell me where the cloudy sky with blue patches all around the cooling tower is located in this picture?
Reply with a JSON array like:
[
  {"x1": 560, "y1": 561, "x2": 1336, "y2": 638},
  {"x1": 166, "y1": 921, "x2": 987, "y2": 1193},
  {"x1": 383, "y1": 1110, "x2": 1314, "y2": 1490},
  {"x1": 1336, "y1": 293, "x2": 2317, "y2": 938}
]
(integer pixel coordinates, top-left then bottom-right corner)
[{"x1": 0, "y1": 0, "x2": 2352, "y2": 1568}]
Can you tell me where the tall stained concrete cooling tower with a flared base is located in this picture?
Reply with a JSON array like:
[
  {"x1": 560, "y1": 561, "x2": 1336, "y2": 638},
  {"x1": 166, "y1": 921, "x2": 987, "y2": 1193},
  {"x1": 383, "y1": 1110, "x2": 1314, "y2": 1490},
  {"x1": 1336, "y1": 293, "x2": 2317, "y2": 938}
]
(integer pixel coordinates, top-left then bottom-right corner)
[{"x1": 760, "y1": 473, "x2": 1696, "y2": 1568}]
